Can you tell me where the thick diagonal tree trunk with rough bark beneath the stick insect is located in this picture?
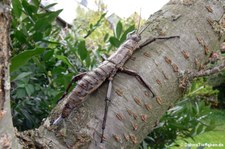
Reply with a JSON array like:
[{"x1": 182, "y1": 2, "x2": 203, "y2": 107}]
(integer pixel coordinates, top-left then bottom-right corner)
[{"x1": 2, "y1": 0, "x2": 225, "y2": 149}]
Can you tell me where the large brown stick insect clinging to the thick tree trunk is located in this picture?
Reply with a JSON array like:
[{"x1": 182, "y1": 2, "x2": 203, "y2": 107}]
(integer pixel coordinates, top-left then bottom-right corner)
[{"x1": 53, "y1": 20, "x2": 179, "y2": 143}]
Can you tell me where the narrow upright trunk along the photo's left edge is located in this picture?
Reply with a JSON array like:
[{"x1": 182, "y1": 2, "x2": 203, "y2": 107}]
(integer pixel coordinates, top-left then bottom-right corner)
[{"x1": 0, "y1": 1, "x2": 19, "y2": 148}]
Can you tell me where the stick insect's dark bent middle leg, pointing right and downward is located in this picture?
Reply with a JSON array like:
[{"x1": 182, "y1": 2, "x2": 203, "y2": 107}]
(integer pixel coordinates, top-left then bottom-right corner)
[{"x1": 119, "y1": 68, "x2": 156, "y2": 97}]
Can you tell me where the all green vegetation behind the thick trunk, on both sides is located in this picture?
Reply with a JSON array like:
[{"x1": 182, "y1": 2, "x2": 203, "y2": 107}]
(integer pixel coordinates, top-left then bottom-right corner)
[{"x1": 10, "y1": 0, "x2": 225, "y2": 149}]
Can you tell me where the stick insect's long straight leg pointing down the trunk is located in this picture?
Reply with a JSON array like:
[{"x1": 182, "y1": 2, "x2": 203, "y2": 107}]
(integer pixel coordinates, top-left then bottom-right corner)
[{"x1": 101, "y1": 77, "x2": 113, "y2": 143}]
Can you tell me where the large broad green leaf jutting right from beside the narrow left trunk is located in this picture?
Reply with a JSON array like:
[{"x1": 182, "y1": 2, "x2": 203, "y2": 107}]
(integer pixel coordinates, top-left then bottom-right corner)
[{"x1": 10, "y1": 48, "x2": 45, "y2": 72}]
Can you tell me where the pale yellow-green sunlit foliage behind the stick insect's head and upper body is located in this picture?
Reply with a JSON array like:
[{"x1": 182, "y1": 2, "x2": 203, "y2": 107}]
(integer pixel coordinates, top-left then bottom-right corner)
[{"x1": 70, "y1": 6, "x2": 135, "y2": 60}]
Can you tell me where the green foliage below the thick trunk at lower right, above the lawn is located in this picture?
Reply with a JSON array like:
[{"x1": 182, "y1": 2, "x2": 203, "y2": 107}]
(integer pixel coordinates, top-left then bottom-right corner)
[{"x1": 140, "y1": 78, "x2": 218, "y2": 149}]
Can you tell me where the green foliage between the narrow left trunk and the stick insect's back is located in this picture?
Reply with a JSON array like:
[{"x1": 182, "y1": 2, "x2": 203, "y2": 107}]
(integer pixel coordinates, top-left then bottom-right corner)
[{"x1": 10, "y1": 0, "x2": 134, "y2": 130}]
